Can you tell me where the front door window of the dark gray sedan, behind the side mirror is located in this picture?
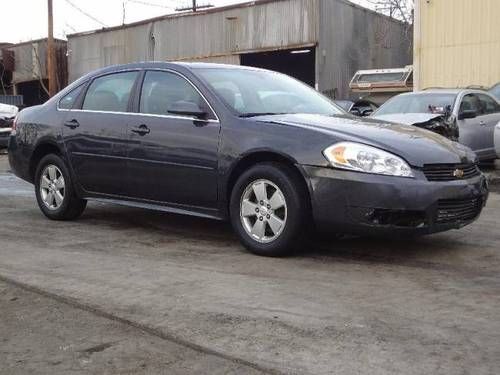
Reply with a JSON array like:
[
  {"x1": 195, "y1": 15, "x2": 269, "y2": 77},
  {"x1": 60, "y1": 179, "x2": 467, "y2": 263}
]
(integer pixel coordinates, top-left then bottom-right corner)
[{"x1": 139, "y1": 71, "x2": 212, "y2": 117}]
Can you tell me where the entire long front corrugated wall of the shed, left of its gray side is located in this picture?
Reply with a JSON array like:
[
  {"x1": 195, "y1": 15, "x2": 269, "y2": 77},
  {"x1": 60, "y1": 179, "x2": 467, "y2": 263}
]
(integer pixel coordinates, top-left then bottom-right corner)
[{"x1": 68, "y1": 0, "x2": 318, "y2": 81}]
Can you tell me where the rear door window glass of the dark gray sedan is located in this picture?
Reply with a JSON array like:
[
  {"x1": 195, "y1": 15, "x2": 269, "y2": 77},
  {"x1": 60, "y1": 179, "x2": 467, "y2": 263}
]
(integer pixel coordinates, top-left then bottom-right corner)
[{"x1": 82, "y1": 72, "x2": 138, "y2": 112}]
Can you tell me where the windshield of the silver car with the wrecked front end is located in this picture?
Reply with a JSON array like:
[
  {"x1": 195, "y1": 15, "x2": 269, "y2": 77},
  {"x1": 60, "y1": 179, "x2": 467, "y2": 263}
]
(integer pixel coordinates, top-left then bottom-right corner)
[{"x1": 375, "y1": 93, "x2": 456, "y2": 115}]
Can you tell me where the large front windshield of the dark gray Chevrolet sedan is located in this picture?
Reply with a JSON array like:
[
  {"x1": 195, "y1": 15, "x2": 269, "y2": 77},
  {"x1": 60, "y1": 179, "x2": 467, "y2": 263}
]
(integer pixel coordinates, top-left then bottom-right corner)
[{"x1": 198, "y1": 68, "x2": 345, "y2": 117}]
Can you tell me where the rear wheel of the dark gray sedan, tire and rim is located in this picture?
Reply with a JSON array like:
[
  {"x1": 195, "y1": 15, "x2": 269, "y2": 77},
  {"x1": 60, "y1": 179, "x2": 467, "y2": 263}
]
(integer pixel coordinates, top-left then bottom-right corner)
[{"x1": 35, "y1": 154, "x2": 87, "y2": 220}]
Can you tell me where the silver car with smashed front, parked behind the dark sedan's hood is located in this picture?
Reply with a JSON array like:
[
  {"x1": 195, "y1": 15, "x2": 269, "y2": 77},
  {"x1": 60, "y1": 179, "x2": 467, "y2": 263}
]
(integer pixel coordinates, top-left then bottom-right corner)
[{"x1": 372, "y1": 89, "x2": 500, "y2": 161}]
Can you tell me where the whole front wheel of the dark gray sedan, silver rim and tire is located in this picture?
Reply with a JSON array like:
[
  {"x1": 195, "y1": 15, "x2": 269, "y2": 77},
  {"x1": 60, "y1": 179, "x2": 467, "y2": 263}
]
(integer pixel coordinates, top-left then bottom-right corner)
[{"x1": 230, "y1": 163, "x2": 310, "y2": 256}]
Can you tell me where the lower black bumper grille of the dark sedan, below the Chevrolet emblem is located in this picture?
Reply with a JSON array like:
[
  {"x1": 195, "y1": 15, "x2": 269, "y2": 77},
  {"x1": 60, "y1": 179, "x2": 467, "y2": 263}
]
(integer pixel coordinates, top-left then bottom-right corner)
[{"x1": 436, "y1": 197, "x2": 483, "y2": 224}]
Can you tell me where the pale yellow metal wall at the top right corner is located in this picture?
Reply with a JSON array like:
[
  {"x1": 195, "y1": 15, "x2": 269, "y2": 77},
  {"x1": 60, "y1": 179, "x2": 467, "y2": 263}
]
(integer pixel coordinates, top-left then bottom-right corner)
[{"x1": 414, "y1": 0, "x2": 500, "y2": 90}]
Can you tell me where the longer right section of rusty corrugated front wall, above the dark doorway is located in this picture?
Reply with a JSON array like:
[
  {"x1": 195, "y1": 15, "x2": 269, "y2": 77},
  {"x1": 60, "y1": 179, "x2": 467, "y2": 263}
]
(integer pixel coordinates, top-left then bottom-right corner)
[{"x1": 148, "y1": 0, "x2": 317, "y2": 60}]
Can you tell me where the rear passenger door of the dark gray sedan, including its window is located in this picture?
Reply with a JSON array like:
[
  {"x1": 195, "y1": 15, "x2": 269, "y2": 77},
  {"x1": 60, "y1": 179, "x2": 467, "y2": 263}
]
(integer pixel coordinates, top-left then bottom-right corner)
[{"x1": 60, "y1": 71, "x2": 139, "y2": 195}]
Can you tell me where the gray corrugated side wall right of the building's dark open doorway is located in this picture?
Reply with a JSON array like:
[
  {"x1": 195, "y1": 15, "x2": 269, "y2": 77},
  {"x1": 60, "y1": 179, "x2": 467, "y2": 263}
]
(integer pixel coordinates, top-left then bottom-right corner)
[{"x1": 316, "y1": 0, "x2": 412, "y2": 98}]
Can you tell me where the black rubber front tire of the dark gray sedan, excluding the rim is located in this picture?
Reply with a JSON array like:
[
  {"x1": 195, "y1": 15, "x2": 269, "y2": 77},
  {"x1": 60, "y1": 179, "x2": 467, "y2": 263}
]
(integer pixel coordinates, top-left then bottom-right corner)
[{"x1": 229, "y1": 162, "x2": 311, "y2": 257}]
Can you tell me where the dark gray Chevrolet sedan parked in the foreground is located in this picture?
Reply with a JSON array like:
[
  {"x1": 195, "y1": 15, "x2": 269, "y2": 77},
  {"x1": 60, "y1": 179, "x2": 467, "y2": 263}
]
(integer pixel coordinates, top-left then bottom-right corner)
[{"x1": 9, "y1": 63, "x2": 488, "y2": 255}]
